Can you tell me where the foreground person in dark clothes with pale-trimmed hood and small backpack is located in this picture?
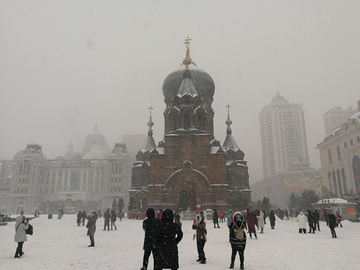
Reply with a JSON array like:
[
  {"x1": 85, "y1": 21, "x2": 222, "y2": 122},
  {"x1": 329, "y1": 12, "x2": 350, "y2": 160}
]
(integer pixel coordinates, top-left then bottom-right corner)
[{"x1": 229, "y1": 212, "x2": 246, "y2": 269}]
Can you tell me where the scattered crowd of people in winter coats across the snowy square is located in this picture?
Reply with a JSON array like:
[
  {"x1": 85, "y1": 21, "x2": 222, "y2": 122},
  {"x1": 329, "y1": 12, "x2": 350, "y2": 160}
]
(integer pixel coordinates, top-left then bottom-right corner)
[{"x1": 14, "y1": 208, "x2": 342, "y2": 270}]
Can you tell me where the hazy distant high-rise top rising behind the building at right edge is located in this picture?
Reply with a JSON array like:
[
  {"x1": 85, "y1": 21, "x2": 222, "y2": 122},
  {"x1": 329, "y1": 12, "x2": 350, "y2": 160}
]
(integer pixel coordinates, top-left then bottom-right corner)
[{"x1": 324, "y1": 107, "x2": 358, "y2": 135}]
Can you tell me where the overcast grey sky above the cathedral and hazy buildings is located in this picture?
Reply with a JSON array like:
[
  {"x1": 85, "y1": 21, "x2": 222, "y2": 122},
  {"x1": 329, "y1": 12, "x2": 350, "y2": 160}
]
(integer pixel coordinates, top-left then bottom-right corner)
[{"x1": 0, "y1": 0, "x2": 360, "y2": 182}]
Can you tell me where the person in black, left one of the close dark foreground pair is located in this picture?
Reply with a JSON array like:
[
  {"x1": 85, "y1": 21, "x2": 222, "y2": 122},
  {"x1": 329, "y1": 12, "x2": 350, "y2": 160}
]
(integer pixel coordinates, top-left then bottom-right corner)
[{"x1": 141, "y1": 208, "x2": 161, "y2": 270}]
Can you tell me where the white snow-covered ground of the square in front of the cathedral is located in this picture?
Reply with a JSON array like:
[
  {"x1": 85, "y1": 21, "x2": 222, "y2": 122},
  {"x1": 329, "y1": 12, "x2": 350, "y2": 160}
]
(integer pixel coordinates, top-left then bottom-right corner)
[{"x1": 0, "y1": 215, "x2": 360, "y2": 270}]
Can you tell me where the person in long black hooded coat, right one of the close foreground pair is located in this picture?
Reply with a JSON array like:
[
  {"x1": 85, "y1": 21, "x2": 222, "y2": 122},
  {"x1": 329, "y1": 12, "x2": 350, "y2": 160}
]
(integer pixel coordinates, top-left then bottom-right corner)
[{"x1": 158, "y1": 209, "x2": 183, "y2": 270}]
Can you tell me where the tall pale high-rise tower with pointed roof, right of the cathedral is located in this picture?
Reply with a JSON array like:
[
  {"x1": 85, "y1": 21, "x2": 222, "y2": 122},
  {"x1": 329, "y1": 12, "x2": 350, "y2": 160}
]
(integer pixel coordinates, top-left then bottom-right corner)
[{"x1": 259, "y1": 93, "x2": 310, "y2": 178}]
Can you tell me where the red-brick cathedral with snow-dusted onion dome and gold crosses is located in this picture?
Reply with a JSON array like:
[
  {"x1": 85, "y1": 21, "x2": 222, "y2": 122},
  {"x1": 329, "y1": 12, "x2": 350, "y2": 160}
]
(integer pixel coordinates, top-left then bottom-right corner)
[{"x1": 128, "y1": 38, "x2": 251, "y2": 217}]
